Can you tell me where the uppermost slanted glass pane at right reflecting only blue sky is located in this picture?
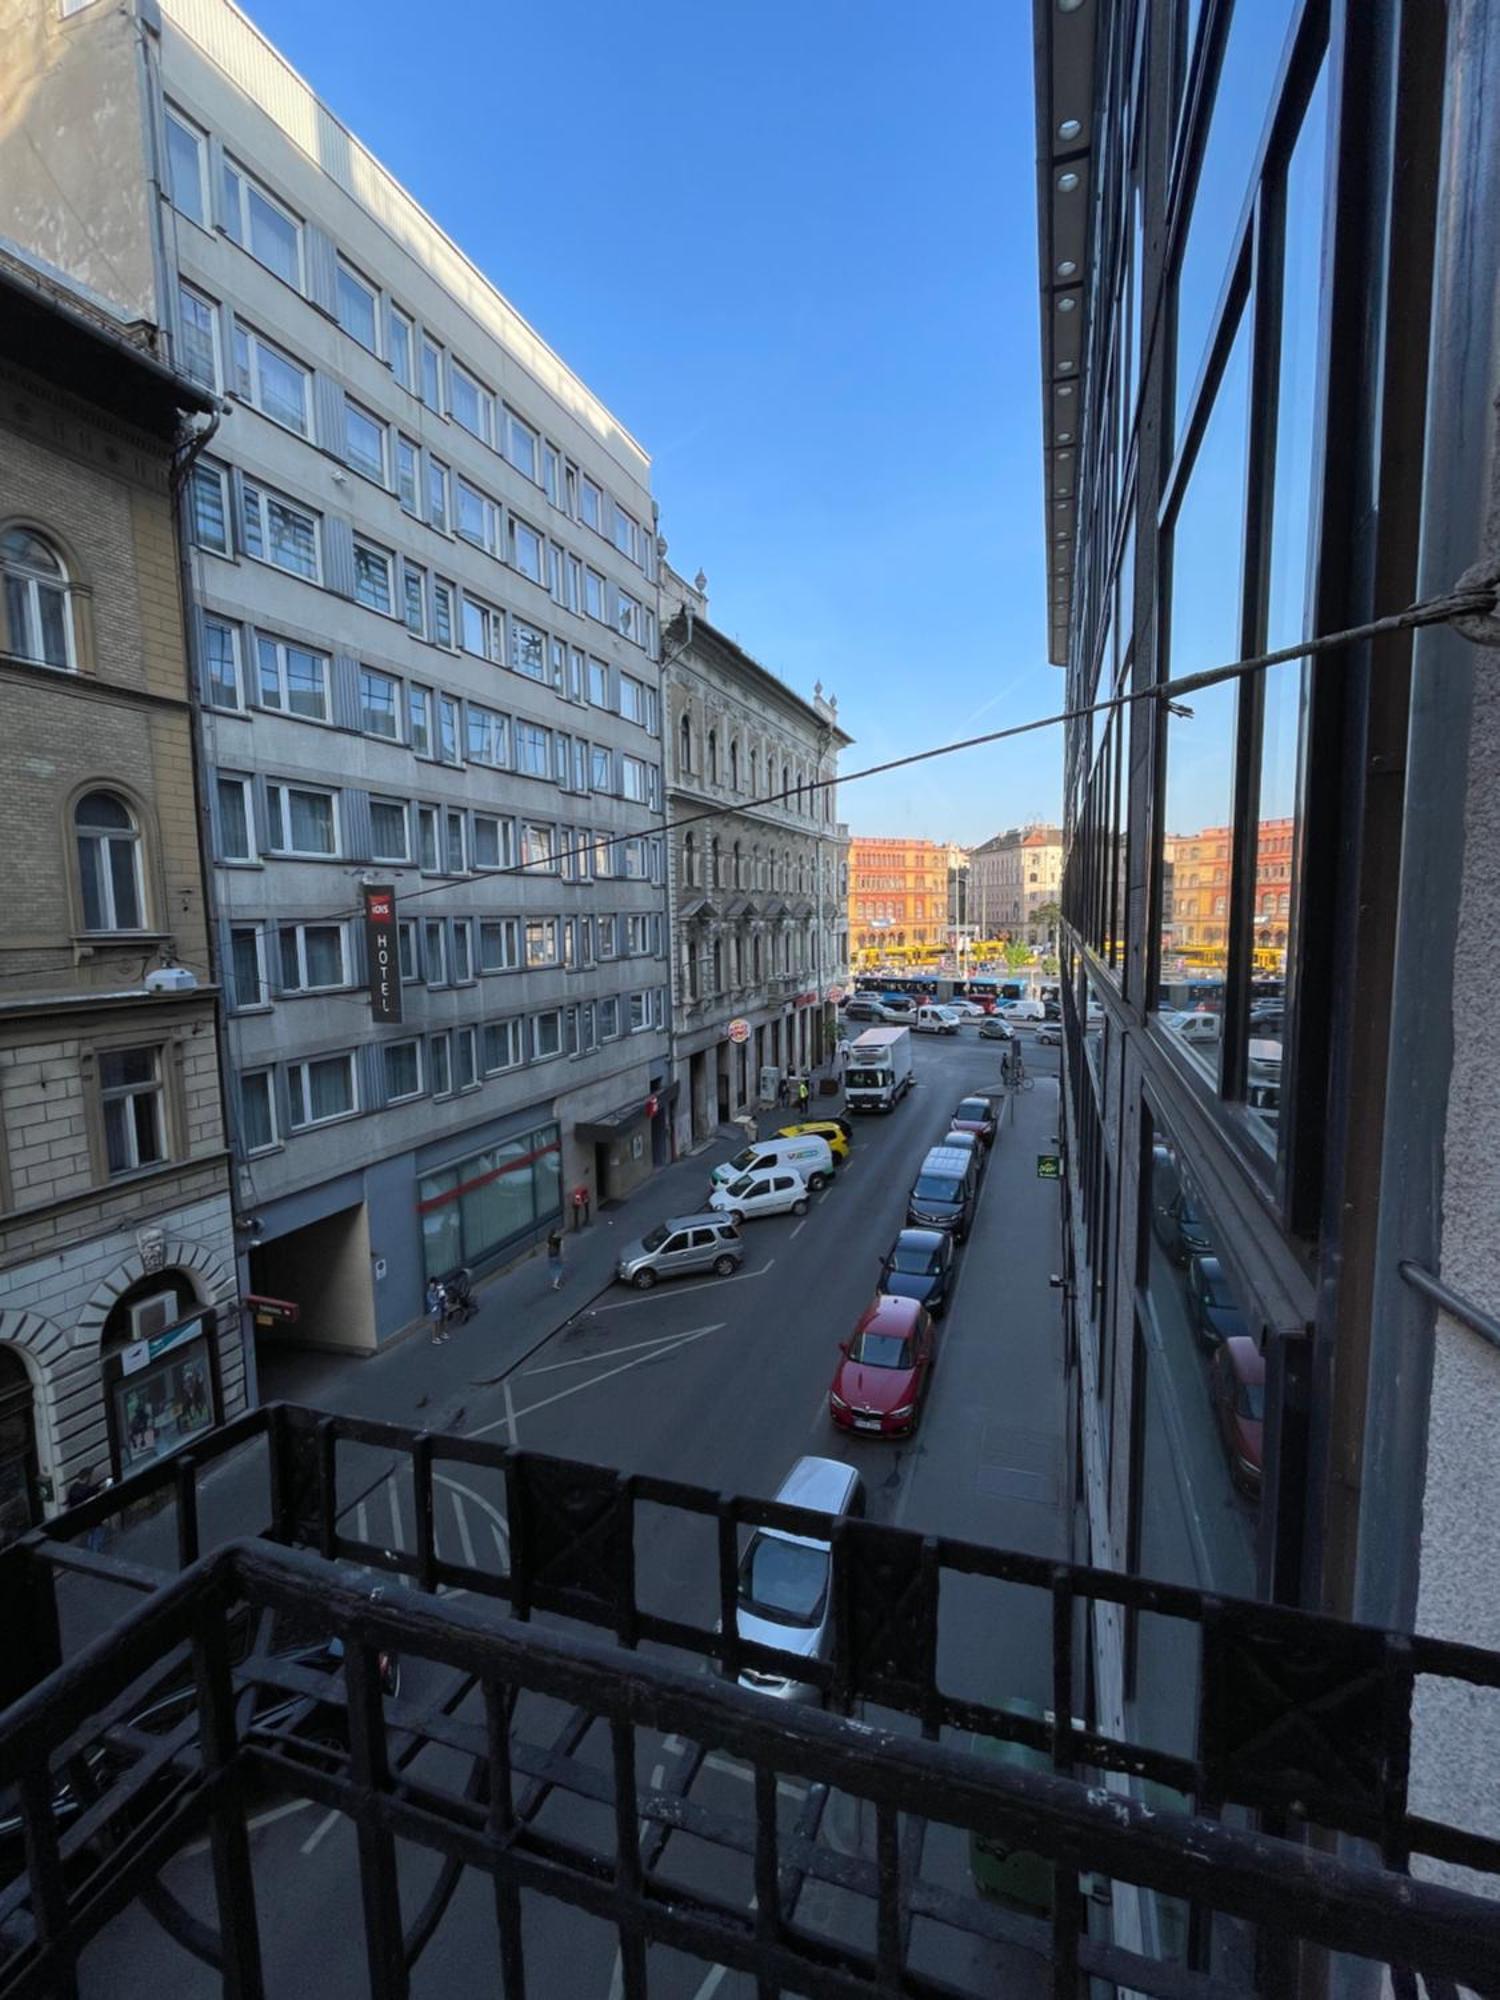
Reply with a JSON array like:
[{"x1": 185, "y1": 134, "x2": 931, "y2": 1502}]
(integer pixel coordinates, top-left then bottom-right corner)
[{"x1": 1174, "y1": 0, "x2": 1294, "y2": 438}]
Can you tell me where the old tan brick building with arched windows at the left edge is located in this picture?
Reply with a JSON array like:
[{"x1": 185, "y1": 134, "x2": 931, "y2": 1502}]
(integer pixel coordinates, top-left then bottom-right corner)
[{"x1": 0, "y1": 252, "x2": 246, "y2": 1544}]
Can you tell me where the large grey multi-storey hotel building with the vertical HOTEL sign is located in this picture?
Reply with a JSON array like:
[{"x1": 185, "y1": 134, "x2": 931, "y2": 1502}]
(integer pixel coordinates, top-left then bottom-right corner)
[{"x1": 0, "y1": 0, "x2": 670, "y2": 1348}]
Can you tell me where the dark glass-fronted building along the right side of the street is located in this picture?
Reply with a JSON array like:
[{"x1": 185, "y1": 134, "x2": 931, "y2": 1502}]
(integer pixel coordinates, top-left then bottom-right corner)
[{"x1": 1036, "y1": 0, "x2": 1500, "y2": 1944}]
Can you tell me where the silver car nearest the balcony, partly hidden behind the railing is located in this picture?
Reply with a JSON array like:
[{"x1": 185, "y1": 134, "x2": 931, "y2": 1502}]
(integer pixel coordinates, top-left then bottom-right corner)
[{"x1": 734, "y1": 1458, "x2": 864, "y2": 1702}]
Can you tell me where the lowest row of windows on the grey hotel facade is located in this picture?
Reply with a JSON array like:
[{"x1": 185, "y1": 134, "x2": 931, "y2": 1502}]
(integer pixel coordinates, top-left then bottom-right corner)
[{"x1": 238, "y1": 986, "x2": 666, "y2": 1164}]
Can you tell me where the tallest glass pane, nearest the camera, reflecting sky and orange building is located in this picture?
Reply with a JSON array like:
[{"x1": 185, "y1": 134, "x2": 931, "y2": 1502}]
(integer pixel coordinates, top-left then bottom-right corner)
[{"x1": 1244, "y1": 74, "x2": 1328, "y2": 1144}]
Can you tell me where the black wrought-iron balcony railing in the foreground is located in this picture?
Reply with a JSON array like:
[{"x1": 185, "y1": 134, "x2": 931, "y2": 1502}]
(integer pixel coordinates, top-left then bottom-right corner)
[{"x1": 0, "y1": 1406, "x2": 1500, "y2": 2000}]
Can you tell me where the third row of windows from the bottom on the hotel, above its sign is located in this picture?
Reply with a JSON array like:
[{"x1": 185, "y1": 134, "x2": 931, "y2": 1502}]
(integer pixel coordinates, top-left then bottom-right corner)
[{"x1": 212, "y1": 770, "x2": 662, "y2": 882}]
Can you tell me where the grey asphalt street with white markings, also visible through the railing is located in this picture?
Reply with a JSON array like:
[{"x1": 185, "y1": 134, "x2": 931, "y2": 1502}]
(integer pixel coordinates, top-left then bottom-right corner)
[{"x1": 64, "y1": 1030, "x2": 1068, "y2": 2000}]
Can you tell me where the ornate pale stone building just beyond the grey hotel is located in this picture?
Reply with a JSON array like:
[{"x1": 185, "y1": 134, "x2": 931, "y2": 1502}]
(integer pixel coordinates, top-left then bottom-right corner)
[{"x1": 662, "y1": 566, "x2": 852, "y2": 1148}]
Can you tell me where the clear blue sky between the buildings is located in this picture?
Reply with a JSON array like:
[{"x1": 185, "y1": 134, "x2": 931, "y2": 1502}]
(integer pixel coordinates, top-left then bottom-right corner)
[{"x1": 248, "y1": 0, "x2": 1062, "y2": 842}]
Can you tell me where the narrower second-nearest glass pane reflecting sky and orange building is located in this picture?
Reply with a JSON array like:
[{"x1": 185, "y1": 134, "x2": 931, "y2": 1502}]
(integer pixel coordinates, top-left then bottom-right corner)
[{"x1": 1156, "y1": 312, "x2": 1250, "y2": 1078}]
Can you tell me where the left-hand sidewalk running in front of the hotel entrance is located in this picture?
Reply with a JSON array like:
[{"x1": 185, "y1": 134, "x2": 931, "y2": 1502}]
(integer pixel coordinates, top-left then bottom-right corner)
[{"x1": 258, "y1": 1096, "x2": 842, "y2": 1430}]
